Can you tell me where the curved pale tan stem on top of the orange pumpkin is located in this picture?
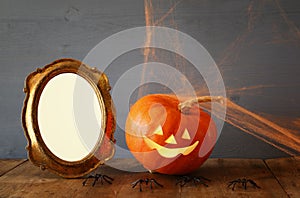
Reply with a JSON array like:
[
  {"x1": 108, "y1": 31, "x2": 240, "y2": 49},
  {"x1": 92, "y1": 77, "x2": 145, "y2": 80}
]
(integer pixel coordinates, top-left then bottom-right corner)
[{"x1": 178, "y1": 96, "x2": 225, "y2": 114}]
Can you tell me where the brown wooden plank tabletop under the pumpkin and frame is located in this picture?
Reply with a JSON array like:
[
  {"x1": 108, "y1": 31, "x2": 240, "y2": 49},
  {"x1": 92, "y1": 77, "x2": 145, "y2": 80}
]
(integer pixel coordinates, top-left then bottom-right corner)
[{"x1": 0, "y1": 157, "x2": 300, "y2": 198}]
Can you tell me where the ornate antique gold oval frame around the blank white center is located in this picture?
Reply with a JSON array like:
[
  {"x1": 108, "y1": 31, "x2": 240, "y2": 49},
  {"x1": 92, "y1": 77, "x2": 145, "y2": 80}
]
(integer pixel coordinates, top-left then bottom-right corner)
[{"x1": 22, "y1": 59, "x2": 116, "y2": 178}]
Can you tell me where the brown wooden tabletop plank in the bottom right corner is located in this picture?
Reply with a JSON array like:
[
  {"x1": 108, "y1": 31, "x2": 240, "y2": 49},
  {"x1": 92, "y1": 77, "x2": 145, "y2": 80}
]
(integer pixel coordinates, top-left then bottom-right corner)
[{"x1": 266, "y1": 157, "x2": 300, "y2": 197}]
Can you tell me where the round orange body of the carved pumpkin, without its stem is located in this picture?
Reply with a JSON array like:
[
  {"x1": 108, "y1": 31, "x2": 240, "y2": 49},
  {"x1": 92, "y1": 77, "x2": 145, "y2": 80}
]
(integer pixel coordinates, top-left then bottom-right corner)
[{"x1": 125, "y1": 94, "x2": 217, "y2": 175}]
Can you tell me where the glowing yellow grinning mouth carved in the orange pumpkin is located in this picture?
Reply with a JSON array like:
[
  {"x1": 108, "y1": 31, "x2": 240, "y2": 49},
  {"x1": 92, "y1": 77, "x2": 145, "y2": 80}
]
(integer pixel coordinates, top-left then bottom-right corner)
[{"x1": 143, "y1": 136, "x2": 199, "y2": 158}]
